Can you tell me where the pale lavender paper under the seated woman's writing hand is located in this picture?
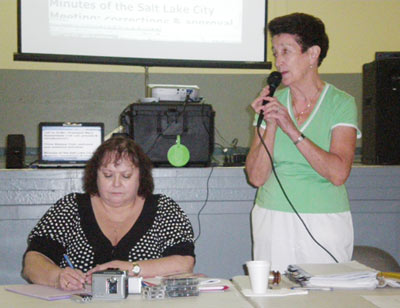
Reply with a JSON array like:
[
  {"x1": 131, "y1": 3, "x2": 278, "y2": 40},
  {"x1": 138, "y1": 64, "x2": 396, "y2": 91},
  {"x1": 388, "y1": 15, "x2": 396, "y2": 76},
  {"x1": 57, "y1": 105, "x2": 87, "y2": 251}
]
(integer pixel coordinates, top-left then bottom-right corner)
[{"x1": 5, "y1": 284, "x2": 87, "y2": 301}]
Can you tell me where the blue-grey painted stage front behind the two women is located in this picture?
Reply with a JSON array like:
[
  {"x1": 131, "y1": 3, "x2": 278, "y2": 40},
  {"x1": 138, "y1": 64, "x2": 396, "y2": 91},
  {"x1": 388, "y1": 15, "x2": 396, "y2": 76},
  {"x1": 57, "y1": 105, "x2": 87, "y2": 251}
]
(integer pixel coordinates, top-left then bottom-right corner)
[{"x1": 0, "y1": 166, "x2": 400, "y2": 284}]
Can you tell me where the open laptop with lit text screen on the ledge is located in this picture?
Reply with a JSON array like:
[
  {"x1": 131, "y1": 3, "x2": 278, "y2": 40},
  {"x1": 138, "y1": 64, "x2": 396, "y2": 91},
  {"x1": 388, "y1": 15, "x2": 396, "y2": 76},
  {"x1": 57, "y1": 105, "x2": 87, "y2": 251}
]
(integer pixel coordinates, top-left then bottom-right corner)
[{"x1": 37, "y1": 122, "x2": 104, "y2": 168}]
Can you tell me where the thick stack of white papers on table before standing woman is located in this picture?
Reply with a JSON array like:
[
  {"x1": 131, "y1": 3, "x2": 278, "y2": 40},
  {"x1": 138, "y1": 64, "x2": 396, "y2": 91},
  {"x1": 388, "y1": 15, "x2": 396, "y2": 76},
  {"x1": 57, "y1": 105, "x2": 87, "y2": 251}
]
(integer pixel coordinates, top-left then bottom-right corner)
[{"x1": 288, "y1": 261, "x2": 379, "y2": 289}]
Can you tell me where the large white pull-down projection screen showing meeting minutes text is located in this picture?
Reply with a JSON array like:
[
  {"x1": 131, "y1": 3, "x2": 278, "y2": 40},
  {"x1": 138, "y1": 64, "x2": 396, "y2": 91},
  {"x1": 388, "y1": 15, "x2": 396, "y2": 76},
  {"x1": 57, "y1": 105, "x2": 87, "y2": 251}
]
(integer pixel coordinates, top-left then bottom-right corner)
[{"x1": 14, "y1": 0, "x2": 270, "y2": 68}]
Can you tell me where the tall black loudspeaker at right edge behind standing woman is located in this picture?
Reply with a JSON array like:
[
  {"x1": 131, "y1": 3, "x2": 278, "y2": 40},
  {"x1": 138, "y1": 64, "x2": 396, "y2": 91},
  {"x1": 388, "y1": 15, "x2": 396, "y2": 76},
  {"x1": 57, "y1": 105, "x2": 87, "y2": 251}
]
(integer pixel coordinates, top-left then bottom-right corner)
[{"x1": 361, "y1": 56, "x2": 400, "y2": 165}]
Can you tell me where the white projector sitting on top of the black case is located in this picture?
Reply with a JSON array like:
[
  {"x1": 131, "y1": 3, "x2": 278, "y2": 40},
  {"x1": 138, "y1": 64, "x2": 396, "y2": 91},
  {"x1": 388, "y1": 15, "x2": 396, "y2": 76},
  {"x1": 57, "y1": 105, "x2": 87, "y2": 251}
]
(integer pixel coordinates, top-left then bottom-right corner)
[{"x1": 146, "y1": 84, "x2": 200, "y2": 102}]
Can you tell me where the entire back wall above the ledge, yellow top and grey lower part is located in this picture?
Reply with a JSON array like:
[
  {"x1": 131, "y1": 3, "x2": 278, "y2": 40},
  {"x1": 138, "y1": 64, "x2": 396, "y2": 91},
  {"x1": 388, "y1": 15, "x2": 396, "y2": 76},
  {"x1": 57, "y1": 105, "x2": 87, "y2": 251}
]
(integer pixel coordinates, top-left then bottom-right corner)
[{"x1": 0, "y1": 0, "x2": 400, "y2": 152}]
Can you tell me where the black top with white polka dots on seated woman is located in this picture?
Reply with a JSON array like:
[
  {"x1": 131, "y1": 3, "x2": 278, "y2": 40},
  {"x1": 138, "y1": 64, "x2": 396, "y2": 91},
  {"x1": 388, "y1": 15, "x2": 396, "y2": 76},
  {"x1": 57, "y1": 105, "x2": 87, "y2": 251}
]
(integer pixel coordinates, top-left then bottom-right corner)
[{"x1": 27, "y1": 193, "x2": 195, "y2": 272}]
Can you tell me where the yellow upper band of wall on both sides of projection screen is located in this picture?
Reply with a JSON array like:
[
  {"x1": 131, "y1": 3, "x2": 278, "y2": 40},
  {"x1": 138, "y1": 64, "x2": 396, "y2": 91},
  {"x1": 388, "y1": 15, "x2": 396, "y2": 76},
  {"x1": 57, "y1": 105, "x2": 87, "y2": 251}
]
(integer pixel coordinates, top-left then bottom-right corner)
[{"x1": 0, "y1": 0, "x2": 400, "y2": 74}]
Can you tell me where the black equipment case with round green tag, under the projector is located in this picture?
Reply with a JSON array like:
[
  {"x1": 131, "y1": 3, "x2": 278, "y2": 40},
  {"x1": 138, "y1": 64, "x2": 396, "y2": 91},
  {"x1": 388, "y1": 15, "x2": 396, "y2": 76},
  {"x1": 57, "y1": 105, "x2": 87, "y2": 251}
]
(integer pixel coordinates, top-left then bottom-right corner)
[{"x1": 120, "y1": 102, "x2": 215, "y2": 167}]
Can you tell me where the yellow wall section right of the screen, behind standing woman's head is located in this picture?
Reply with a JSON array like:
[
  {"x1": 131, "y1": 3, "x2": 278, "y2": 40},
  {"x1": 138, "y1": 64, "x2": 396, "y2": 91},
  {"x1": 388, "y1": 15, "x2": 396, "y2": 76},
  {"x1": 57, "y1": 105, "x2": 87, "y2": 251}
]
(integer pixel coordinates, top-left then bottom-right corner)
[{"x1": 269, "y1": 0, "x2": 400, "y2": 74}]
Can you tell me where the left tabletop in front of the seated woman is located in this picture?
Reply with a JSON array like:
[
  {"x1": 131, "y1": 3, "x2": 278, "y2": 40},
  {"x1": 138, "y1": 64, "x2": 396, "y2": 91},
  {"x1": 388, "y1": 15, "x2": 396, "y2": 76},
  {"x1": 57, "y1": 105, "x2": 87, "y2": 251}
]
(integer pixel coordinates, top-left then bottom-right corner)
[{"x1": 0, "y1": 279, "x2": 252, "y2": 308}]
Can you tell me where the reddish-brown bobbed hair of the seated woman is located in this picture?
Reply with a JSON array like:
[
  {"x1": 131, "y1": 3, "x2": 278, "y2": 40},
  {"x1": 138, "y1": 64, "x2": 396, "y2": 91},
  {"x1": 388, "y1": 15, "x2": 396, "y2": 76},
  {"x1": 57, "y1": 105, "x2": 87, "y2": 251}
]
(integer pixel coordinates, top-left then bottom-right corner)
[{"x1": 83, "y1": 136, "x2": 154, "y2": 198}]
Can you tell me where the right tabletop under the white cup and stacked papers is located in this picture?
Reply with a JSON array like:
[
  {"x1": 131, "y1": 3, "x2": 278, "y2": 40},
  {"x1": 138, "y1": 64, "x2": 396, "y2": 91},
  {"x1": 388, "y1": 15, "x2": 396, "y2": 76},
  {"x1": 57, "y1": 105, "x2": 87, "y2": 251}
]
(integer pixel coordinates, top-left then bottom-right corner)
[{"x1": 232, "y1": 276, "x2": 400, "y2": 308}]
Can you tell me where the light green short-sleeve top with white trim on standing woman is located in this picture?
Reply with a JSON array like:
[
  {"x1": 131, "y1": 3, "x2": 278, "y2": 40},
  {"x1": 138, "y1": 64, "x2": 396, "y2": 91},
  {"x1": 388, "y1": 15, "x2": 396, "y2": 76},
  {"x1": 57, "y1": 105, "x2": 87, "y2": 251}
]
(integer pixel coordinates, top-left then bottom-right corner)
[{"x1": 255, "y1": 83, "x2": 361, "y2": 213}]
